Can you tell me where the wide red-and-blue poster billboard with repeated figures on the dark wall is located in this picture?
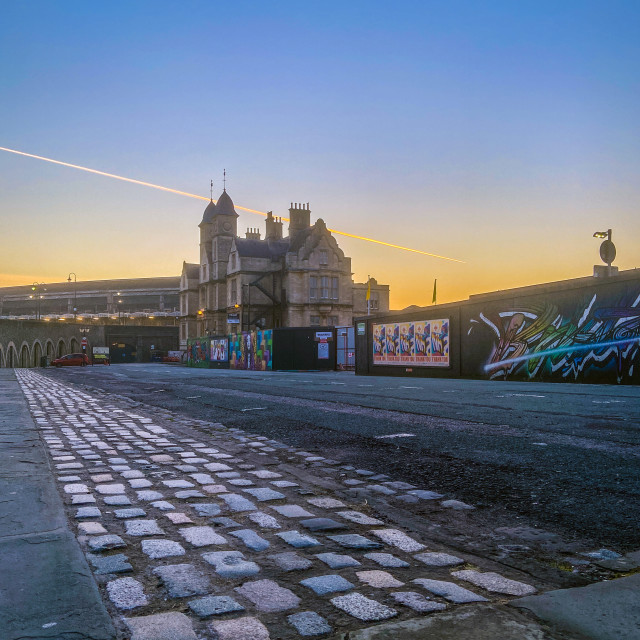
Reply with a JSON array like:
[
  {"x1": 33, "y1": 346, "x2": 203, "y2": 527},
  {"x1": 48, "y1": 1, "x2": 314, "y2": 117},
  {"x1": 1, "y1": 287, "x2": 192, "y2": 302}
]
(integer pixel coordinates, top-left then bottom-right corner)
[{"x1": 373, "y1": 318, "x2": 449, "y2": 367}]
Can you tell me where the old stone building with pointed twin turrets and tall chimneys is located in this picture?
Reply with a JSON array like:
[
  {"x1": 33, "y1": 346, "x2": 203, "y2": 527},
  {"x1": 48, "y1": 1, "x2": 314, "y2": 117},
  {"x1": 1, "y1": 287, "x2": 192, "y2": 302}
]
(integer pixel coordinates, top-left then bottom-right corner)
[{"x1": 180, "y1": 189, "x2": 389, "y2": 348}]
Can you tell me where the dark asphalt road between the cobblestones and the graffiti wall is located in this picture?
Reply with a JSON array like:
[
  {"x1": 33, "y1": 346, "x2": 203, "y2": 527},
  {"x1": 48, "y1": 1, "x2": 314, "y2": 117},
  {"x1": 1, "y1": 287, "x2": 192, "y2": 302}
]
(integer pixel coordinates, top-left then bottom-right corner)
[{"x1": 46, "y1": 364, "x2": 640, "y2": 551}]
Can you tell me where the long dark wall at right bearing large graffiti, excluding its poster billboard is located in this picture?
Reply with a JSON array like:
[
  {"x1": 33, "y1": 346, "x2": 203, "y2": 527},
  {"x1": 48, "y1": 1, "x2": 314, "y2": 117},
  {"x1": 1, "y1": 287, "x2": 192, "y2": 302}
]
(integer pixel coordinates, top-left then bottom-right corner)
[{"x1": 355, "y1": 270, "x2": 640, "y2": 384}]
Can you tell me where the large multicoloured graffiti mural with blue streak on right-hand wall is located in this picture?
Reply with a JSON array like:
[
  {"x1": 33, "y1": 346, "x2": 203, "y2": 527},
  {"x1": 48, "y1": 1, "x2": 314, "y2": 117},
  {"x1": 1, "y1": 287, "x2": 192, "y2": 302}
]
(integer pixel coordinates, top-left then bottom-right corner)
[{"x1": 467, "y1": 288, "x2": 640, "y2": 383}]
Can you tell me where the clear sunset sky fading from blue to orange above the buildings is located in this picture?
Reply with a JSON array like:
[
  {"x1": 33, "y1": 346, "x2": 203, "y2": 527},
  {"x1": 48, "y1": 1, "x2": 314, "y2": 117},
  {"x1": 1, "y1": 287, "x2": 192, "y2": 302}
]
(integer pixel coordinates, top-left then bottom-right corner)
[{"x1": 0, "y1": 0, "x2": 640, "y2": 308}]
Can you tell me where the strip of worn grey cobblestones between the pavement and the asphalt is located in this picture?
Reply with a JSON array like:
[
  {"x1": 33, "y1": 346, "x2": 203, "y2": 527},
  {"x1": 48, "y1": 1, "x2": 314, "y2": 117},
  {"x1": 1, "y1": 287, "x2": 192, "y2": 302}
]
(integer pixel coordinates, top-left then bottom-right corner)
[{"x1": 16, "y1": 370, "x2": 543, "y2": 640}]
